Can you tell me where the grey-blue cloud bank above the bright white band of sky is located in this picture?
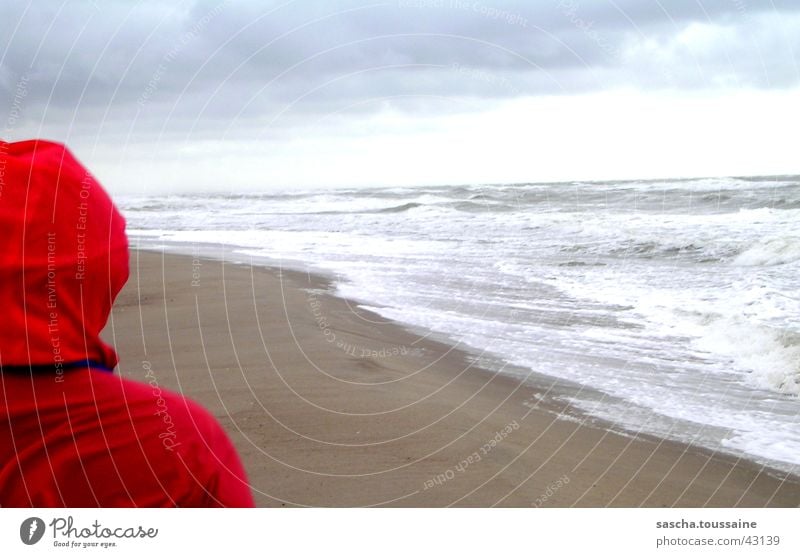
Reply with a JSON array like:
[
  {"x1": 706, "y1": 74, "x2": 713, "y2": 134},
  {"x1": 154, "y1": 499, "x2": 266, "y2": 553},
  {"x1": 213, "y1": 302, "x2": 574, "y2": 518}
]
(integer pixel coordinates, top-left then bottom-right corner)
[{"x1": 0, "y1": 0, "x2": 800, "y2": 137}]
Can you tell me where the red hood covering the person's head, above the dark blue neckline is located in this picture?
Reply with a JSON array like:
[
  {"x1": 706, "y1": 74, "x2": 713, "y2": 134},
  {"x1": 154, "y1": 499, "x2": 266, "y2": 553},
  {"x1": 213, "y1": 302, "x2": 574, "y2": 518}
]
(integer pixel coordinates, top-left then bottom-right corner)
[{"x1": 0, "y1": 141, "x2": 128, "y2": 369}]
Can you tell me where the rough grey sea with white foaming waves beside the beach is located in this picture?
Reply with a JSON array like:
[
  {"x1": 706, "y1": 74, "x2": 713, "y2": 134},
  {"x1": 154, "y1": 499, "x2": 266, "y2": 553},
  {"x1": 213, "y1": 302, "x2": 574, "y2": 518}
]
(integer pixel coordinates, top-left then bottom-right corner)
[{"x1": 118, "y1": 176, "x2": 800, "y2": 473}]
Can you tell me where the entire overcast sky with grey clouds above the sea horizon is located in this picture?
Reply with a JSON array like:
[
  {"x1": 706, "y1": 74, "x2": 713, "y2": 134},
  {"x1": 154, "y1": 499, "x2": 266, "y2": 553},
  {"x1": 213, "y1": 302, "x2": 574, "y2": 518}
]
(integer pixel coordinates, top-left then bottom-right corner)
[{"x1": 0, "y1": 0, "x2": 800, "y2": 193}]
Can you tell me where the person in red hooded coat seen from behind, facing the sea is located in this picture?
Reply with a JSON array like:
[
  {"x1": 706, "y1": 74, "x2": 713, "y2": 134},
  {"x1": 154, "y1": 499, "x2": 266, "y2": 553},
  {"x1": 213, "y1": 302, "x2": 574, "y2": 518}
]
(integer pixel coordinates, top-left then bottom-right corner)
[{"x1": 0, "y1": 141, "x2": 253, "y2": 507}]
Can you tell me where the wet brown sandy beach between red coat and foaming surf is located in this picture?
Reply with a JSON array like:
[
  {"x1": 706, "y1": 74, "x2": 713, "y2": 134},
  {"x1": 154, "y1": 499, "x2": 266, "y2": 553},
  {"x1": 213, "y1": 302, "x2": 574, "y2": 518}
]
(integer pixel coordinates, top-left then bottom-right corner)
[{"x1": 104, "y1": 250, "x2": 800, "y2": 507}]
